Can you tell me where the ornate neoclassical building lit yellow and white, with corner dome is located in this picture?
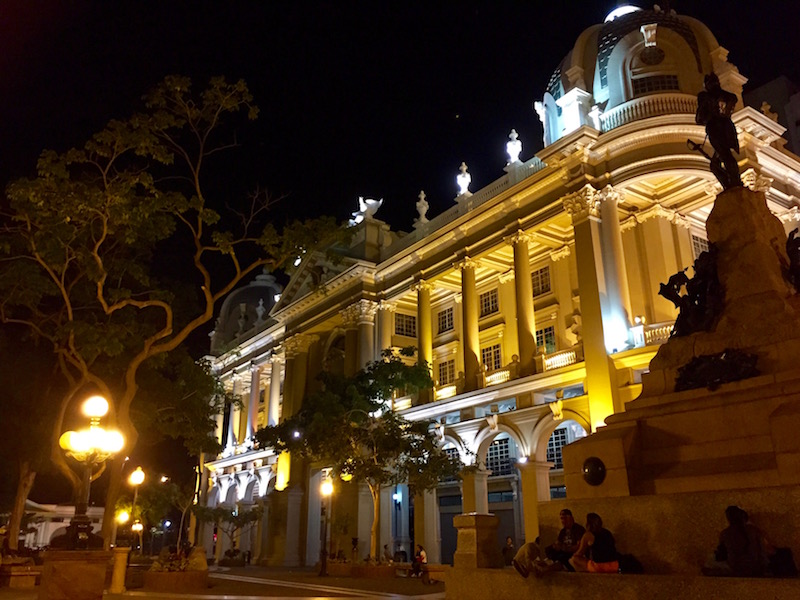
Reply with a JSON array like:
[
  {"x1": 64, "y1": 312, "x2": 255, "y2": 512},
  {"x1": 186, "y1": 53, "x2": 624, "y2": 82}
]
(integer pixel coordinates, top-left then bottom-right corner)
[{"x1": 195, "y1": 9, "x2": 800, "y2": 566}]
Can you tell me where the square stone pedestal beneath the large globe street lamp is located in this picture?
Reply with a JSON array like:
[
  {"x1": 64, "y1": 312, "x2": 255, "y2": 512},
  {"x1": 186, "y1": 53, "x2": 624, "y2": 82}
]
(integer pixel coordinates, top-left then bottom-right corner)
[{"x1": 39, "y1": 550, "x2": 111, "y2": 600}]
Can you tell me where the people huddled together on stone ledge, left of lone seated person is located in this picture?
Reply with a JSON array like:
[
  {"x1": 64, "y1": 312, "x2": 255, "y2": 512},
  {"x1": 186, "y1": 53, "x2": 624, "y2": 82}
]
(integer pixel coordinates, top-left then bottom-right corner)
[{"x1": 504, "y1": 508, "x2": 619, "y2": 577}]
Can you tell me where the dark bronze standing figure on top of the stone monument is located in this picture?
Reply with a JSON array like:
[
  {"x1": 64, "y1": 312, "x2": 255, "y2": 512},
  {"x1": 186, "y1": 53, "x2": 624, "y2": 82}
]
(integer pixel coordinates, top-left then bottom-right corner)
[{"x1": 688, "y1": 73, "x2": 742, "y2": 190}]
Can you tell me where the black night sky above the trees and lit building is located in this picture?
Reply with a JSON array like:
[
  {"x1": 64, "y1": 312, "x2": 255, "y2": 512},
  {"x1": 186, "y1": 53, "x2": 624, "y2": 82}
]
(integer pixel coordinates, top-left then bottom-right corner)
[{"x1": 0, "y1": 0, "x2": 800, "y2": 501}]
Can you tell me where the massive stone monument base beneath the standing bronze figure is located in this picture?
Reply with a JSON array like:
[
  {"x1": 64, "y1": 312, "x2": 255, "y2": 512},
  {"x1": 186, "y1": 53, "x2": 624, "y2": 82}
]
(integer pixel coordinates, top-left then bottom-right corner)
[{"x1": 564, "y1": 186, "x2": 800, "y2": 573}]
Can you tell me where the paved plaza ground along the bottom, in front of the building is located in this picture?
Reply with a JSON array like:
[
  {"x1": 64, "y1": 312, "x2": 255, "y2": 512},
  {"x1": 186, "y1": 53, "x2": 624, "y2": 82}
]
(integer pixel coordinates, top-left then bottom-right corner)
[{"x1": 0, "y1": 567, "x2": 444, "y2": 600}]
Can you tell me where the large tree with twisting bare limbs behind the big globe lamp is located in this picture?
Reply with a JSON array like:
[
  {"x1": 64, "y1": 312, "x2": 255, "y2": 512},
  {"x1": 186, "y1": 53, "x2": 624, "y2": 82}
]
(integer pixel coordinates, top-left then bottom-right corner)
[{"x1": 0, "y1": 76, "x2": 343, "y2": 544}]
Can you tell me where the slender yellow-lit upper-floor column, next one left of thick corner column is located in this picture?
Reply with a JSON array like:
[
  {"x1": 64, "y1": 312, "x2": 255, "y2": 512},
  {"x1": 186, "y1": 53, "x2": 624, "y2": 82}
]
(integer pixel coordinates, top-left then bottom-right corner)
[{"x1": 506, "y1": 230, "x2": 536, "y2": 377}]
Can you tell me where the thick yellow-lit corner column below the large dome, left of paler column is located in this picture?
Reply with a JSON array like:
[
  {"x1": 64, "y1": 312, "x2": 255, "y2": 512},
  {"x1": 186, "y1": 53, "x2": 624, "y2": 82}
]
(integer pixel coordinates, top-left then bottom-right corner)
[{"x1": 562, "y1": 184, "x2": 619, "y2": 431}]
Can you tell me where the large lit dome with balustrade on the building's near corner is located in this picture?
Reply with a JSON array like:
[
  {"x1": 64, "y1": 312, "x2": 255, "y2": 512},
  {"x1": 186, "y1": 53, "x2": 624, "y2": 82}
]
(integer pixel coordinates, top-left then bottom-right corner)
[{"x1": 536, "y1": 6, "x2": 743, "y2": 146}]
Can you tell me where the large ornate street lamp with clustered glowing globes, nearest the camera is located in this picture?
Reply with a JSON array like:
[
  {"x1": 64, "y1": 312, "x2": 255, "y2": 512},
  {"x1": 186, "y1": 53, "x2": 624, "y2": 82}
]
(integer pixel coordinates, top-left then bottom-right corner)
[{"x1": 58, "y1": 396, "x2": 125, "y2": 550}]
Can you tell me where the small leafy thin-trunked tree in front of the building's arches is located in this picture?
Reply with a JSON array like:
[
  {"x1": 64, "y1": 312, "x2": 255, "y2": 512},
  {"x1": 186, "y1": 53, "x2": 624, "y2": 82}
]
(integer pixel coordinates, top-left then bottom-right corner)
[{"x1": 256, "y1": 348, "x2": 460, "y2": 557}]
